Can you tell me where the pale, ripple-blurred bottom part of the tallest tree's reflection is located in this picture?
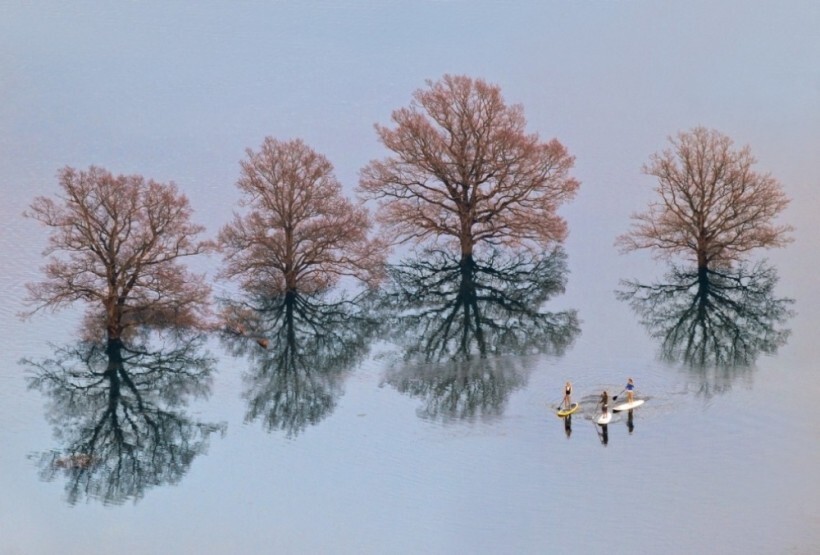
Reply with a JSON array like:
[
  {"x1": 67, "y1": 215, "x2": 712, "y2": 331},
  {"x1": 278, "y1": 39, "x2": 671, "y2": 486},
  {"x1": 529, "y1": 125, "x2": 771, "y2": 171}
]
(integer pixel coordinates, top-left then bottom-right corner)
[{"x1": 386, "y1": 357, "x2": 527, "y2": 421}]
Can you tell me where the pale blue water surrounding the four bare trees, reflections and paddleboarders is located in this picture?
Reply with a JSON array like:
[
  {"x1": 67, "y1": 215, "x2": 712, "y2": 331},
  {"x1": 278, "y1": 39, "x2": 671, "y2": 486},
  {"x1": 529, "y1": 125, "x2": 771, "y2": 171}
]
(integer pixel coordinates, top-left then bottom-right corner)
[{"x1": 0, "y1": 1, "x2": 820, "y2": 555}]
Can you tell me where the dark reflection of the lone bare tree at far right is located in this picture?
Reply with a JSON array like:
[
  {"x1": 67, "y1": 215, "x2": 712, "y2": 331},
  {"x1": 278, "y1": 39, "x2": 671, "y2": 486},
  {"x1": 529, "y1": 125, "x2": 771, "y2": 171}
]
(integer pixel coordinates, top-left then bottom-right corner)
[{"x1": 616, "y1": 262, "x2": 794, "y2": 396}]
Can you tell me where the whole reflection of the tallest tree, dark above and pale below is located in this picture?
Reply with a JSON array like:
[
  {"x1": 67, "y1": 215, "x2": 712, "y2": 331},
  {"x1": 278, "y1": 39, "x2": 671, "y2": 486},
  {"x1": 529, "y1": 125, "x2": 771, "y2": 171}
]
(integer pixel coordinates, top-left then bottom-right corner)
[{"x1": 380, "y1": 249, "x2": 580, "y2": 420}]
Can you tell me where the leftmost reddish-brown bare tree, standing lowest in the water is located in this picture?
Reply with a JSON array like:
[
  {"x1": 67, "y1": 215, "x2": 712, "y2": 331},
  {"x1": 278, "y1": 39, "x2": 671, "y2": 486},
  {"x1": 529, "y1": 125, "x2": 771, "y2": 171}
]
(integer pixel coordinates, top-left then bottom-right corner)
[{"x1": 25, "y1": 166, "x2": 210, "y2": 352}]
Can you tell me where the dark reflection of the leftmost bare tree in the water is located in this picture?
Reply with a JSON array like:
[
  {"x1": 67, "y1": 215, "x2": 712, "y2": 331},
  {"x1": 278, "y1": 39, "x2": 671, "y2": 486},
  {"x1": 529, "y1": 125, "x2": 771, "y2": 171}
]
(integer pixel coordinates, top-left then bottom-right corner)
[{"x1": 23, "y1": 338, "x2": 224, "y2": 504}]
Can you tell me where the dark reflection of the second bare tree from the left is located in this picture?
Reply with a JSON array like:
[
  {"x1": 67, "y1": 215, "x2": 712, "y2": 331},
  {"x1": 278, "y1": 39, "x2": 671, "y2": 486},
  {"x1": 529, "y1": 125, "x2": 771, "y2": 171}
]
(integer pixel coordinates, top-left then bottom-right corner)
[{"x1": 218, "y1": 292, "x2": 377, "y2": 436}]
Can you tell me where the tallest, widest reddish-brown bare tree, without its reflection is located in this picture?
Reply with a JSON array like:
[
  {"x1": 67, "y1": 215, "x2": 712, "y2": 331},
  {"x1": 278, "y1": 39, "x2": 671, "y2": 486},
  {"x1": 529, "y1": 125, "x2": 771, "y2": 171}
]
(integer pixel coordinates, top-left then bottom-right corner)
[{"x1": 359, "y1": 75, "x2": 579, "y2": 260}]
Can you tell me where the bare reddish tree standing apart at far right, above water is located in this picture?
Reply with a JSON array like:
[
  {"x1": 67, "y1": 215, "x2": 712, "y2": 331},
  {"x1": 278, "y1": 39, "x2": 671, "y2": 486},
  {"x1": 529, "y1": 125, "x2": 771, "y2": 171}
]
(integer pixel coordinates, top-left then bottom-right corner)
[{"x1": 616, "y1": 127, "x2": 792, "y2": 269}]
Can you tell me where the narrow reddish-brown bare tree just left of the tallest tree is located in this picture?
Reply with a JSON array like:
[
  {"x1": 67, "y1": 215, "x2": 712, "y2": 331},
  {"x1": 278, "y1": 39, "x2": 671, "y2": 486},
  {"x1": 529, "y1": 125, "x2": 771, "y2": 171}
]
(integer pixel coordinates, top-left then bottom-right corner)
[{"x1": 219, "y1": 137, "x2": 385, "y2": 296}]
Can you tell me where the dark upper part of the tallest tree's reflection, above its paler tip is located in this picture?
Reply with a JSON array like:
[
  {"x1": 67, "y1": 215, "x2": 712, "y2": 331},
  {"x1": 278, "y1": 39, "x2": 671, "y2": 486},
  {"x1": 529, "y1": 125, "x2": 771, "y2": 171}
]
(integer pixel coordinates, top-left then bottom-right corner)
[{"x1": 382, "y1": 249, "x2": 579, "y2": 361}]
